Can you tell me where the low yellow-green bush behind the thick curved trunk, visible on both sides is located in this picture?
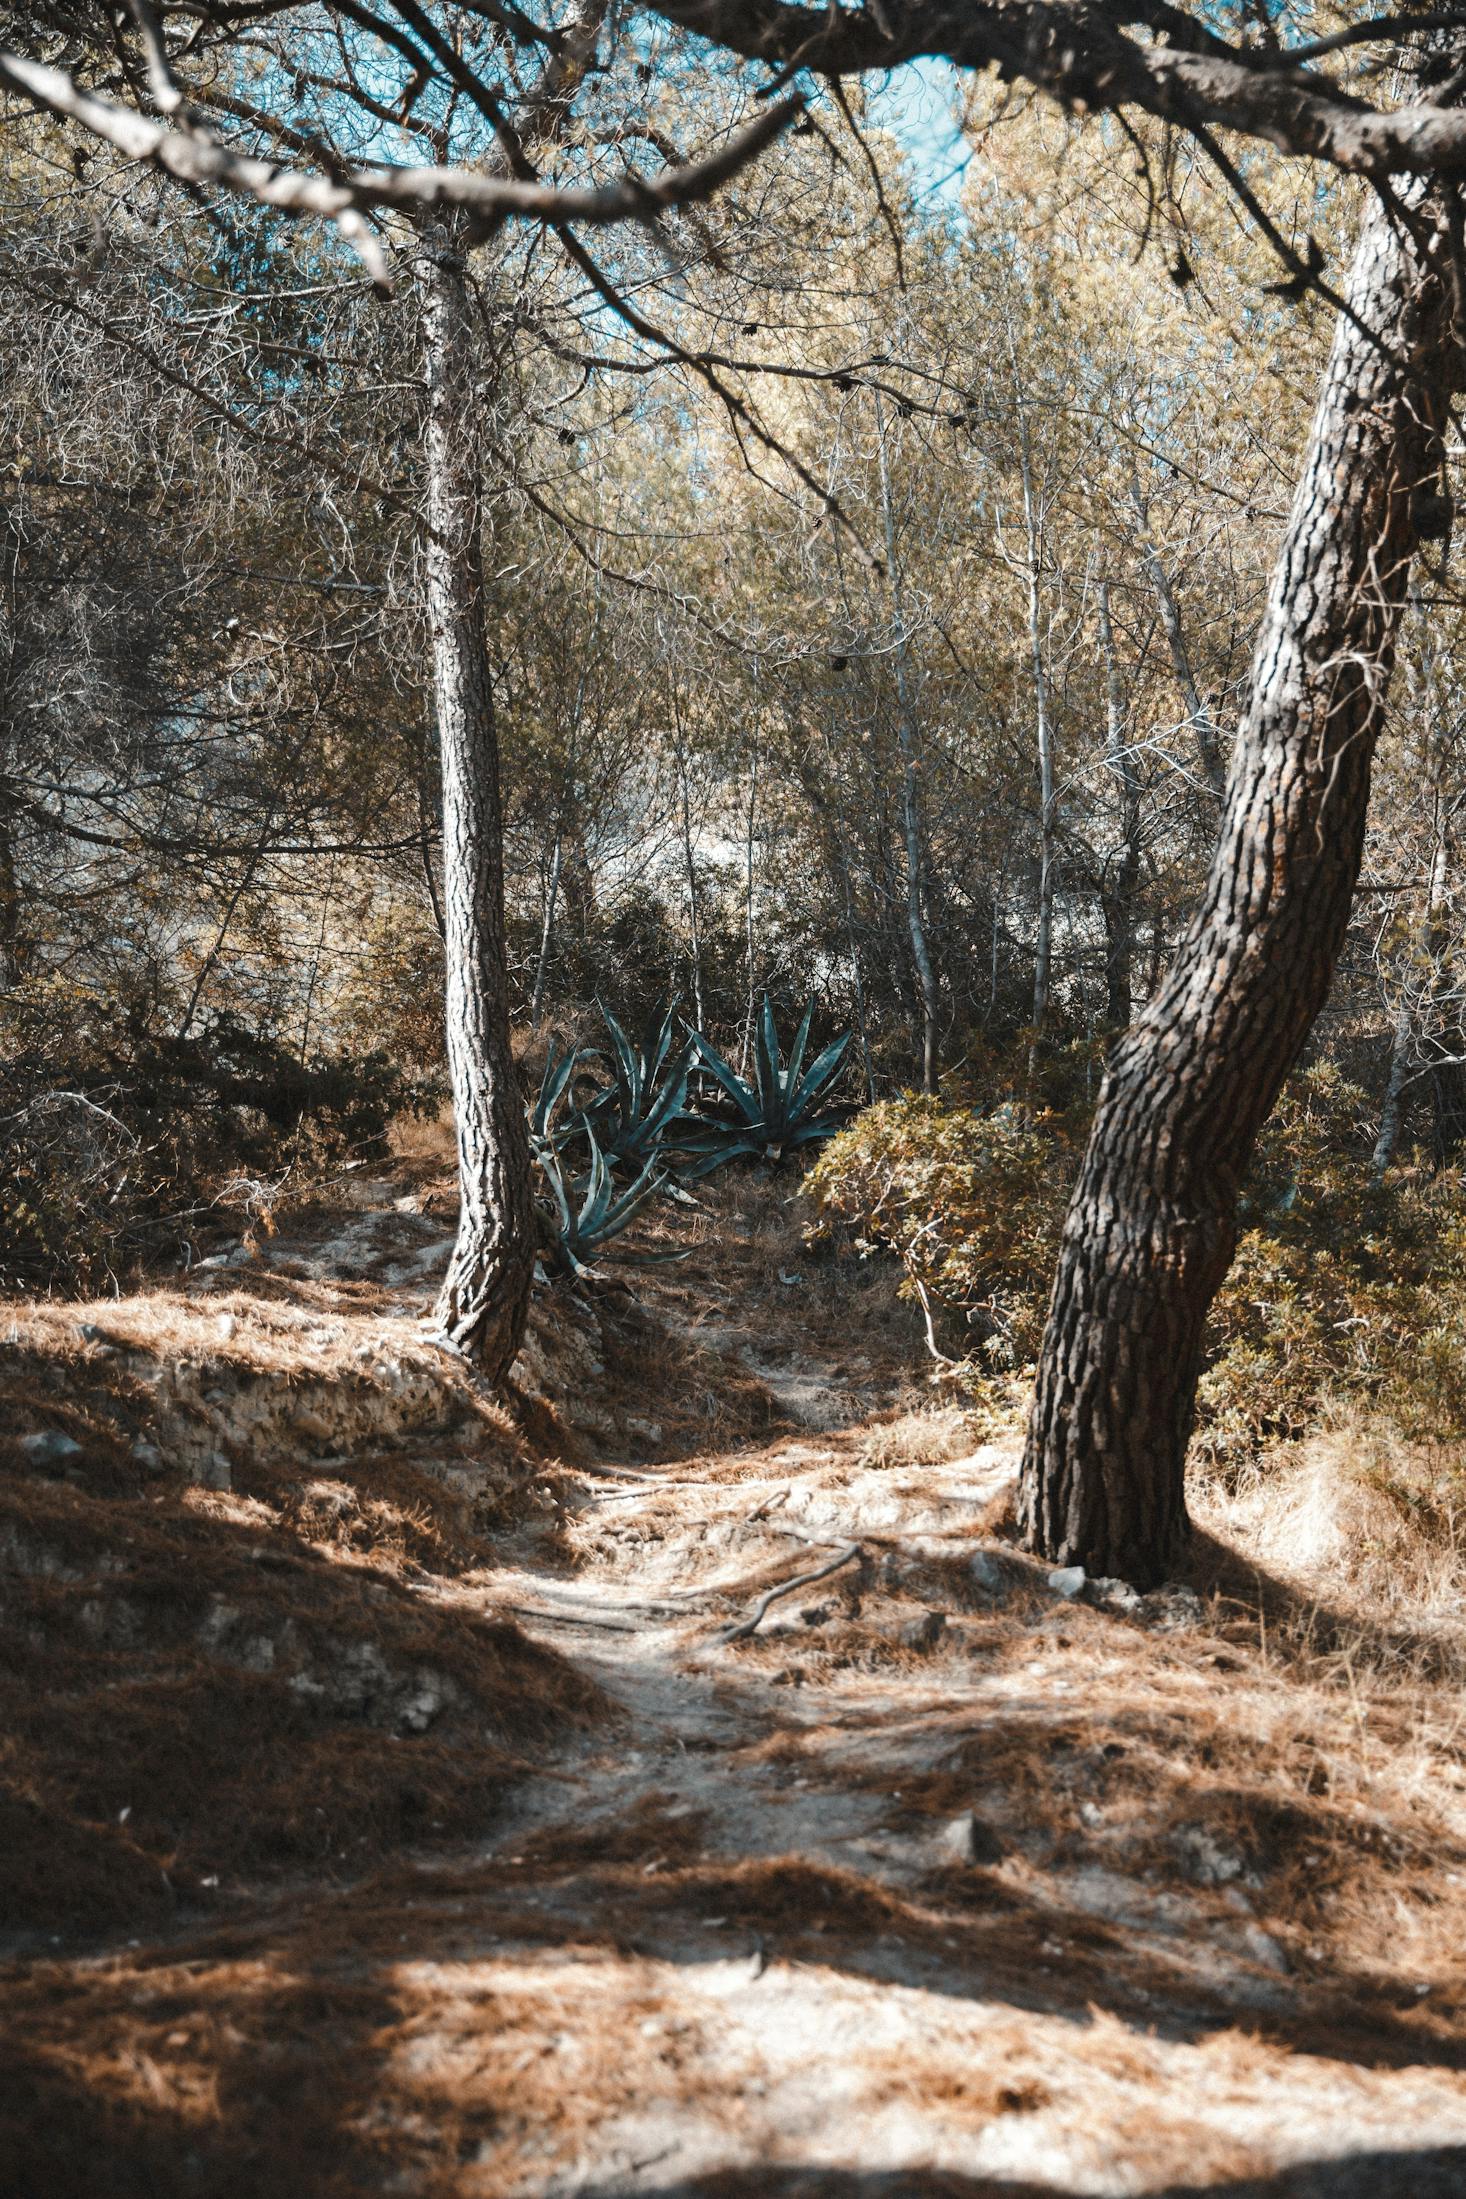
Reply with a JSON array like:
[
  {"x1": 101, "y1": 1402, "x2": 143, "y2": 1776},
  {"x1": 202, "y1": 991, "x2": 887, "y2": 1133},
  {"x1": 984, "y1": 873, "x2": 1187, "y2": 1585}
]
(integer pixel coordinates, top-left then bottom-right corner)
[{"x1": 804, "y1": 1064, "x2": 1466, "y2": 1460}]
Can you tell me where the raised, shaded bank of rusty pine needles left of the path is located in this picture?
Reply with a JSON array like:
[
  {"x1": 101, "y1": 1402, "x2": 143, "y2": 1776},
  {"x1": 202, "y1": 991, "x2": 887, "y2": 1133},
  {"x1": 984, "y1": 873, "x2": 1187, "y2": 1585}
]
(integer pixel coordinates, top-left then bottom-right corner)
[{"x1": 0, "y1": 1240, "x2": 604, "y2": 1940}]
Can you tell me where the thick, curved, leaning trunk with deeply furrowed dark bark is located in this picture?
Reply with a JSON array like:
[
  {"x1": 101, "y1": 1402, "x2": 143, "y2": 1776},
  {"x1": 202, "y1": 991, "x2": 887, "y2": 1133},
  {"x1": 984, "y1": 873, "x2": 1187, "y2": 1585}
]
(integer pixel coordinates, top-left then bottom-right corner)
[{"x1": 1020, "y1": 194, "x2": 1459, "y2": 1585}]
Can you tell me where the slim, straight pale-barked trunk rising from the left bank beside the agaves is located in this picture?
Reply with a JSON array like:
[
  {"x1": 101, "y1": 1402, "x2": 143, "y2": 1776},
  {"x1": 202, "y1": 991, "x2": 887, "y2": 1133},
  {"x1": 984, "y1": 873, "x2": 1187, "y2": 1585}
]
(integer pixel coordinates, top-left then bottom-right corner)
[{"x1": 424, "y1": 235, "x2": 534, "y2": 1381}]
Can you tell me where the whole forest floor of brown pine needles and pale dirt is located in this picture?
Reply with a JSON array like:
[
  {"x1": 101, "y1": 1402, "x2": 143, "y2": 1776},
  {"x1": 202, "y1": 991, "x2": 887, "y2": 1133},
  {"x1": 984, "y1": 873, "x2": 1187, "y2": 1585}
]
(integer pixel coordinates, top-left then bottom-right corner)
[{"x1": 0, "y1": 1157, "x2": 1466, "y2": 2199}]
